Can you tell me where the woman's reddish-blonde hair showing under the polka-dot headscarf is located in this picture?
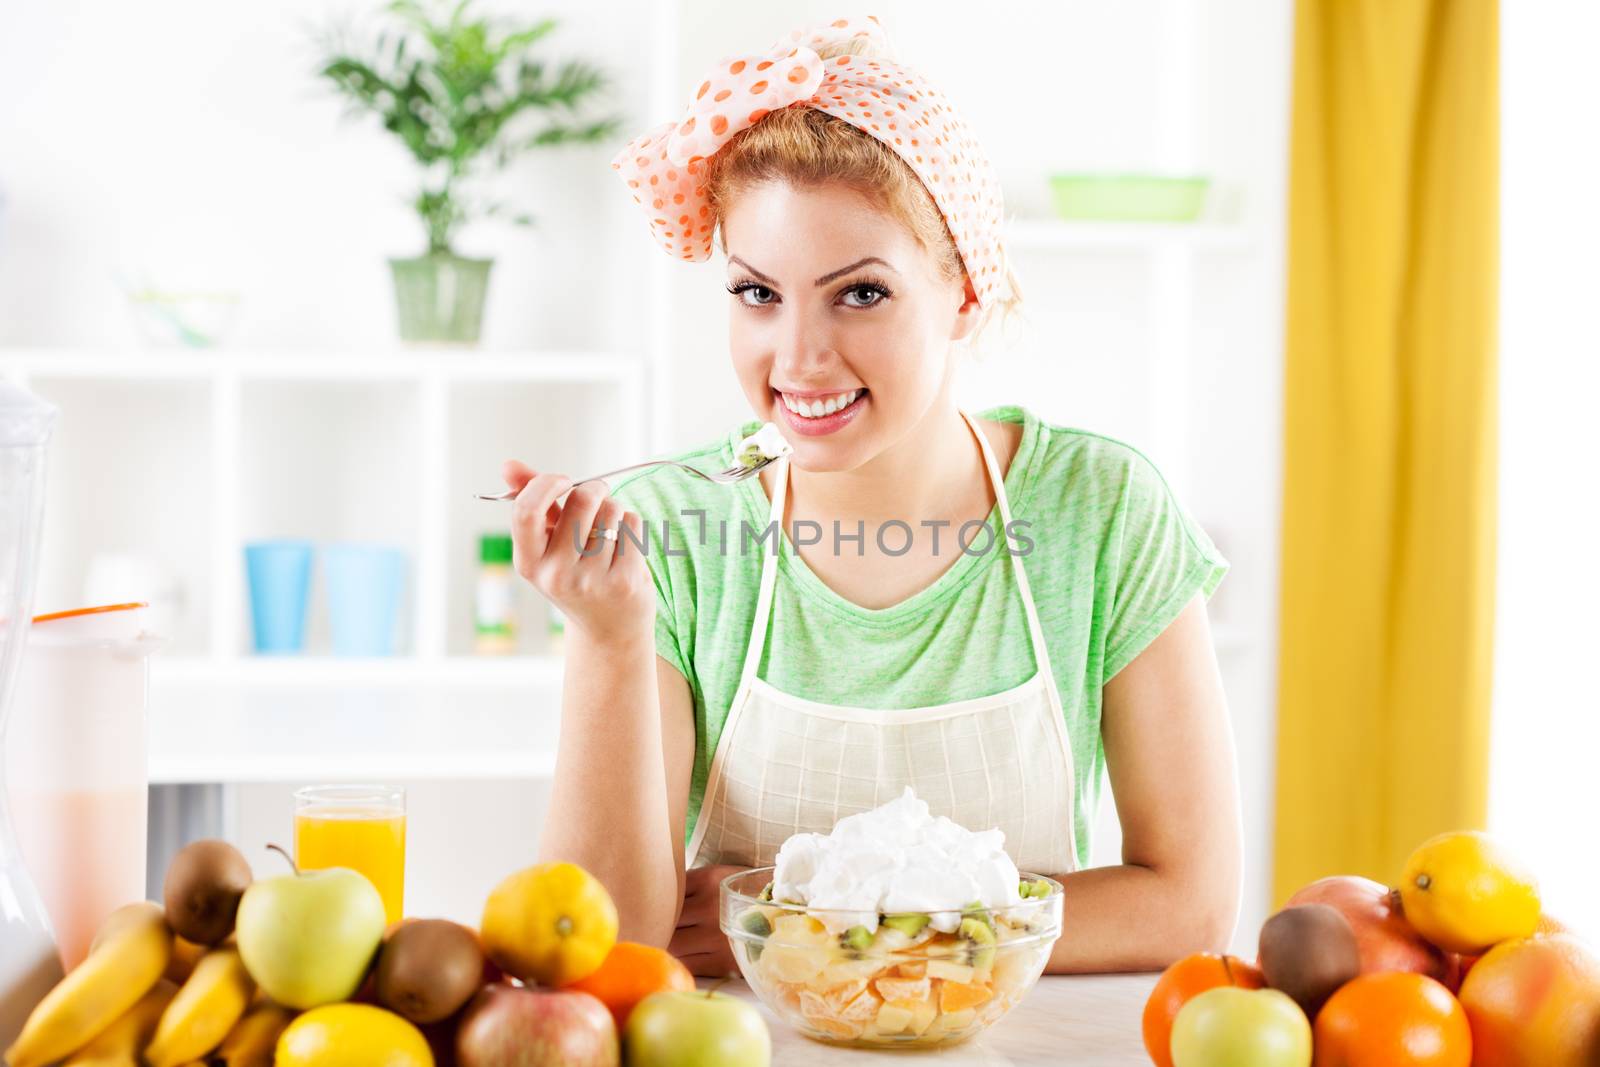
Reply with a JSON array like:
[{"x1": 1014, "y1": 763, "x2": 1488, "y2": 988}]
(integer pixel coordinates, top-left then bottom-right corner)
[{"x1": 706, "y1": 37, "x2": 1022, "y2": 342}]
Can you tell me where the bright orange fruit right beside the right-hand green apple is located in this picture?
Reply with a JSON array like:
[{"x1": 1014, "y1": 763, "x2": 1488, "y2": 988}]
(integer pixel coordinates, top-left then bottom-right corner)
[{"x1": 1312, "y1": 971, "x2": 1474, "y2": 1067}]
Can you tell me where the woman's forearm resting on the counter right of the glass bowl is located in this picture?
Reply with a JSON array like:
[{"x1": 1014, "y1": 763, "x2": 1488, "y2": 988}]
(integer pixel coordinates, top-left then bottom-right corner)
[{"x1": 1046, "y1": 865, "x2": 1238, "y2": 974}]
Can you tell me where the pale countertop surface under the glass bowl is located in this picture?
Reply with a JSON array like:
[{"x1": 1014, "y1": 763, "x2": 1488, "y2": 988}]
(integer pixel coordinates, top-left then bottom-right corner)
[{"x1": 720, "y1": 974, "x2": 1157, "y2": 1067}]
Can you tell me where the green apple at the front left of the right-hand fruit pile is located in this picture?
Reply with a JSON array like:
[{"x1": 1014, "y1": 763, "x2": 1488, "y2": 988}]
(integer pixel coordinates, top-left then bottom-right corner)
[{"x1": 1171, "y1": 985, "x2": 1312, "y2": 1067}]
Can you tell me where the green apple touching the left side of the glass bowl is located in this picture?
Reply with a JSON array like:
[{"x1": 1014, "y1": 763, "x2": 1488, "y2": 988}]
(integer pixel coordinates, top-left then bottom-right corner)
[{"x1": 622, "y1": 989, "x2": 773, "y2": 1067}]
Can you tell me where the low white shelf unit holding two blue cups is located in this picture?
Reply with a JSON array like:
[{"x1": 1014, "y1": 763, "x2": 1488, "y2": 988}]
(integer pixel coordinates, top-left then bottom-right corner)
[{"x1": 0, "y1": 349, "x2": 648, "y2": 782}]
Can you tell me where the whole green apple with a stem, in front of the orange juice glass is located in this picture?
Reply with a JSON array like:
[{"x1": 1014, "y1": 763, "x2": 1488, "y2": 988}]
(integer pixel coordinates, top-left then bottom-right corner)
[{"x1": 235, "y1": 845, "x2": 384, "y2": 1011}]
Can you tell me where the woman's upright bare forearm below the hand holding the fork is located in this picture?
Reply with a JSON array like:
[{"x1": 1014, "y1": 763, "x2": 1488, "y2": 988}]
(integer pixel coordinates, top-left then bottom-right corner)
[{"x1": 539, "y1": 630, "x2": 680, "y2": 945}]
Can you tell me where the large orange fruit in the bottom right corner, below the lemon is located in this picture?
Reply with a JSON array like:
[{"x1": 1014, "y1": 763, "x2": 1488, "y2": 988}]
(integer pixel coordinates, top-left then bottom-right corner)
[{"x1": 1461, "y1": 934, "x2": 1600, "y2": 1067}]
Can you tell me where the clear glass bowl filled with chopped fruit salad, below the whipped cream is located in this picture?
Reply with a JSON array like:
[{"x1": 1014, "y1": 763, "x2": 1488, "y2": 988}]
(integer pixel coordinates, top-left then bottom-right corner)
[{"x1": 720, "y1": 867, "x2": 1061, "y2": 1048}]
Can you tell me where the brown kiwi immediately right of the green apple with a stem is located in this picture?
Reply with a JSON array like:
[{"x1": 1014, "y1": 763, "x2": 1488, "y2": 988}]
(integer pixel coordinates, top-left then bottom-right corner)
[{"x1": 373, "y1": 918, "x2": 483, "y2": 1024}]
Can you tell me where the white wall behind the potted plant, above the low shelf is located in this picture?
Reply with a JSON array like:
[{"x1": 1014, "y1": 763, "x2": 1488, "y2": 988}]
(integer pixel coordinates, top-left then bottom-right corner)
[{"x1": 0, "y1": 0, "x2": 648, "y2": 349}]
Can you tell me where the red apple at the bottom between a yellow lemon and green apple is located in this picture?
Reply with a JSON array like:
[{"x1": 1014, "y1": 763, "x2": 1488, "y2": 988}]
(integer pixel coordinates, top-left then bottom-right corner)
[{"x1": 456, "y1": 984, "x2": 621, "y2": 1067}]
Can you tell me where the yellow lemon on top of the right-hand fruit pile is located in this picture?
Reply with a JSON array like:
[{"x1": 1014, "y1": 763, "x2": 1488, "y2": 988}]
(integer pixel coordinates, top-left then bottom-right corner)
[{"x1": 1400, "y1": 832, "x2": 1539, "y2": 955}]
